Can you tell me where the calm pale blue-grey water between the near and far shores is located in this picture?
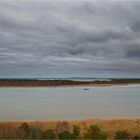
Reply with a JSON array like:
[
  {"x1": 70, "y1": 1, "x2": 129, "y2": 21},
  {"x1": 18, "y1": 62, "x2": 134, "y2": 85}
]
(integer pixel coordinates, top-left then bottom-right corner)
[{"x1": 0, "y1": 86, "x2": 140, "y2": 121}]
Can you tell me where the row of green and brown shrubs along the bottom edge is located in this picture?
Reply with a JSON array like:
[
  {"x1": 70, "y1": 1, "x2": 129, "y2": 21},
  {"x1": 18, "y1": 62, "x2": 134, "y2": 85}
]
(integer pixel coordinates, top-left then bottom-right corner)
[{"x1": 0, "y1": 122, "x2": 140, "y2": 140}]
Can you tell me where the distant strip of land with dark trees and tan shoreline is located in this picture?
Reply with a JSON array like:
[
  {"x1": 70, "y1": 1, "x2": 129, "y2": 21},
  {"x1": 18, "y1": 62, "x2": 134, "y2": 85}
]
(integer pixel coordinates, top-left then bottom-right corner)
[{"x1": 0, "y1": 78, "x2": 140, "y2": 87}]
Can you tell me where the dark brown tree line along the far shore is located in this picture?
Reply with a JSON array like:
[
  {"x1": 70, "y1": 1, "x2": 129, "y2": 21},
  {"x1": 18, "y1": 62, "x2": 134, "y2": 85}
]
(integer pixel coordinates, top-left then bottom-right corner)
[{"x1": 0, "y1": 79, "x2": 140, "y2": 87}]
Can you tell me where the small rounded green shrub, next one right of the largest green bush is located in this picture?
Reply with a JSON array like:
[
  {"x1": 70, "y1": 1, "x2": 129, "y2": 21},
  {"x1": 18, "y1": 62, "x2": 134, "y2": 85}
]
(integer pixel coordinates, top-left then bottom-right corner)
[{"x1": 115, "y1": 130, "x2": 130, "y2": 139}]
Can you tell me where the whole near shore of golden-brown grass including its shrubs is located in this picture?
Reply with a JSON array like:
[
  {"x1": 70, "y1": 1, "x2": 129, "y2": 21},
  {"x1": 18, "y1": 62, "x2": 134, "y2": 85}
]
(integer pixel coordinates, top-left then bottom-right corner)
[{"x1": 0, "y1": 119, "x2": 140, "y2": 139}]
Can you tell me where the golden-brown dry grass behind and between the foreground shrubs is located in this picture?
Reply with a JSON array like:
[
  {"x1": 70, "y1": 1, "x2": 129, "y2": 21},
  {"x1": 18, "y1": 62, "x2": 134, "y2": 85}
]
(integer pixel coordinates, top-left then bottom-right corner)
[{"x1": 0, "y1": 119, "x2": 140, "y2": 138}]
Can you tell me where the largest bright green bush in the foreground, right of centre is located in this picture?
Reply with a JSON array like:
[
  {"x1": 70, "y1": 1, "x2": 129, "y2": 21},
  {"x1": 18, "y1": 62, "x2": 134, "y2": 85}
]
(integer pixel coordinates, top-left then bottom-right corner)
[{"x1": 84, "y1": 125, "x2": 107, "y2": 139}]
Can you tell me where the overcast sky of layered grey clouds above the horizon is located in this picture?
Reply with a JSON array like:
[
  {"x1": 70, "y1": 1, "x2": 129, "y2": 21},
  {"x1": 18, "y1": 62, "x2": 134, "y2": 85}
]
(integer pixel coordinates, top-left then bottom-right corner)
[{"x1": 0, "y1": 0, "x2": 140, "y2": 77}]
